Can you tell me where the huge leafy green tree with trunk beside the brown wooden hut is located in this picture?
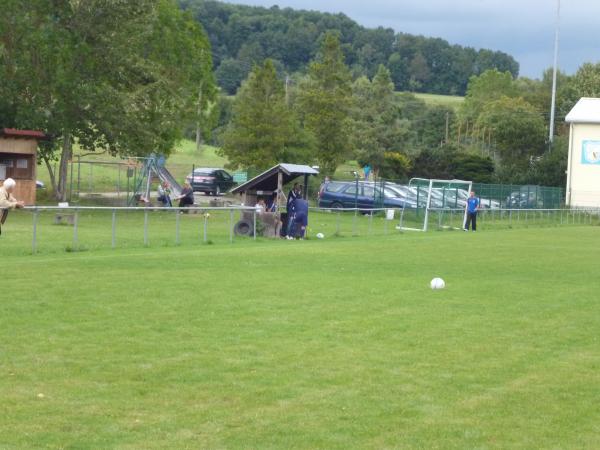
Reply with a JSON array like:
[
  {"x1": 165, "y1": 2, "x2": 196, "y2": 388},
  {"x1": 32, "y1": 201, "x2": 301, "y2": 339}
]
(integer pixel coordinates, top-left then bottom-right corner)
[{"x1": 0, "y1": 0, "x2": 214, "y2": 200}]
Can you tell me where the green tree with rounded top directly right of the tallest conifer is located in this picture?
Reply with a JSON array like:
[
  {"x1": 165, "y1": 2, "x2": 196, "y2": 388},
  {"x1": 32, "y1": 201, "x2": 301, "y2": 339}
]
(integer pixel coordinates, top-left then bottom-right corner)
[{"x1": 353, "y1": 65, "x2": 410, "y2": 174}]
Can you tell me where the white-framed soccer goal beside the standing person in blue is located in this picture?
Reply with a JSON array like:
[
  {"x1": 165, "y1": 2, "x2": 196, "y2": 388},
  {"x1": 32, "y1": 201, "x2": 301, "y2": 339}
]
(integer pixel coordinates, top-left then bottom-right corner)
[{"x1": 397, "y1": 178, "x2": 473, "y2": 231}]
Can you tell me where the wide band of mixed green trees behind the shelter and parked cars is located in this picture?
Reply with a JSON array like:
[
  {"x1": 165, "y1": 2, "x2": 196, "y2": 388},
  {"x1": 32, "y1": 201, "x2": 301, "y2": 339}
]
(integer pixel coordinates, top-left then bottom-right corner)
[{"x1": 218, "y1": 26, "x2": 600, "y2": 186}]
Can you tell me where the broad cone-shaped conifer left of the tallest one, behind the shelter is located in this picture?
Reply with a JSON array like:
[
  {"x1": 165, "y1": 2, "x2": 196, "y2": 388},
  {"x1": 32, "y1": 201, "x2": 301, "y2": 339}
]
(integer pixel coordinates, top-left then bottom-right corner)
[{"x1": 221, "y1": 59, "x2": 308, "y2": 169}]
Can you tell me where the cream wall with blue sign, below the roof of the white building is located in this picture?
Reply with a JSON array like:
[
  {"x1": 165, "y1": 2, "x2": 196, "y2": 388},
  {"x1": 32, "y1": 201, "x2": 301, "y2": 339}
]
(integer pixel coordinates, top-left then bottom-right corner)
[{"x1": 566, "y1": 124, "x2": 600, "y2": 207}]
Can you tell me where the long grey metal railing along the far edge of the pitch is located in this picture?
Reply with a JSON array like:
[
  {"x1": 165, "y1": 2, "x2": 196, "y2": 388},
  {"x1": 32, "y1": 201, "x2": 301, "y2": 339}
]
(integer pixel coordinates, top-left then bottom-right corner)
[{"x1": 0, "y1": 206, "x2": 600, "y2": 254}]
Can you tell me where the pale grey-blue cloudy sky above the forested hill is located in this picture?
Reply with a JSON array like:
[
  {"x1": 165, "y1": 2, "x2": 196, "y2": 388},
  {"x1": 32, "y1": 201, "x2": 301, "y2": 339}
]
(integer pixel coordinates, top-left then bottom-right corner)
[{"x1": 223, "y1": 0, "x2": 600, "y2": 78}]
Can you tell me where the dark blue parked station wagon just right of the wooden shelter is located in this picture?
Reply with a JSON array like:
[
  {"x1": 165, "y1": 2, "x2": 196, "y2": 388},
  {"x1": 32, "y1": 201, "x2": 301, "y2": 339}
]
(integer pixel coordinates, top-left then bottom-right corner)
[{"x1": 319, "y1": 181, "x2": 414, "y2": 210}]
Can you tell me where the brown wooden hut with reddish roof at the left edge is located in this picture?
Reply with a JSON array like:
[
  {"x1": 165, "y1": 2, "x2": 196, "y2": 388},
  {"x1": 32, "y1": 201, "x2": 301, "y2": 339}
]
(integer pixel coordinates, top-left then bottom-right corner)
[{"x1": 0, "y1": 128, "x2": 47, "y2": 205}]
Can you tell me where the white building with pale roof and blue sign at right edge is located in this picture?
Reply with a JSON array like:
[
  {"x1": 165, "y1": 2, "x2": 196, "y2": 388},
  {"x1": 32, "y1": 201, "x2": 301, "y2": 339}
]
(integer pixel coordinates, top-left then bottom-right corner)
[{"x1": 565, "y1": 98, "x2": 600, "y2": 207}]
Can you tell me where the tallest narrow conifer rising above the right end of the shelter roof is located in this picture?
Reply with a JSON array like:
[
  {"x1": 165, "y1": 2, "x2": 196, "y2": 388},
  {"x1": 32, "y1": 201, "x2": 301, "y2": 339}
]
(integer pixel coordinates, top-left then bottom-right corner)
[{"x1": 299, "y1": 33, "x2": 352, "y2": 175}]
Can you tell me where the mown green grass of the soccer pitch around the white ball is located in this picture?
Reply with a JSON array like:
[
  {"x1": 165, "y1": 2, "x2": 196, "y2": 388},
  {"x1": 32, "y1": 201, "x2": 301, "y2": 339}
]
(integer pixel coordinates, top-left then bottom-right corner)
[{"x1": 0, "y1": 215, "x2": 600, "y2": 449}]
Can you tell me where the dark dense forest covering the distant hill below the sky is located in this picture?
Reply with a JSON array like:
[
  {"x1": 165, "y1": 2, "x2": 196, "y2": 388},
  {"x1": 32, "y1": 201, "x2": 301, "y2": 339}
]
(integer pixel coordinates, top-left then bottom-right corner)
[{"x1": 179, "y1": 0, "x2": 519, "y2": 95}]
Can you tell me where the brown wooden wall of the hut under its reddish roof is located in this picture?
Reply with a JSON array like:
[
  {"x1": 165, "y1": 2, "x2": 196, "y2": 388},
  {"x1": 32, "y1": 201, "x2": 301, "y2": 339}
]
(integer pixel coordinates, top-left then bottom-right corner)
[{"x1": 0, "y1": 137, "x2": 37, "y2": 205}]
